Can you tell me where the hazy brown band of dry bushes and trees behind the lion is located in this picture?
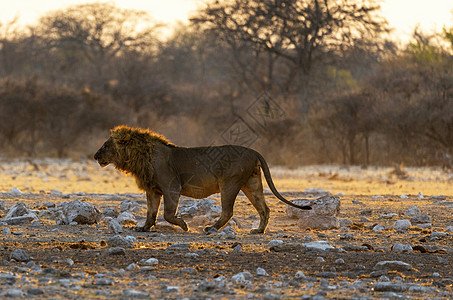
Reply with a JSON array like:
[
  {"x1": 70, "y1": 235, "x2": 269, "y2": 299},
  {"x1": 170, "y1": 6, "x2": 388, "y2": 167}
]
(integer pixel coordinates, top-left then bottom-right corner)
[{"x1": 0, "y1": 0, "x2": 453, "y2": 168}]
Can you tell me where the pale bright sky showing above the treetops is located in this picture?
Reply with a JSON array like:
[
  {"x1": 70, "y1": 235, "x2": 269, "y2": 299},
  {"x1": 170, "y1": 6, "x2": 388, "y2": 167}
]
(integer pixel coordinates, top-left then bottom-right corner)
[{"x1": 0, "y1": 0, "x2": 453, "y2": 41}]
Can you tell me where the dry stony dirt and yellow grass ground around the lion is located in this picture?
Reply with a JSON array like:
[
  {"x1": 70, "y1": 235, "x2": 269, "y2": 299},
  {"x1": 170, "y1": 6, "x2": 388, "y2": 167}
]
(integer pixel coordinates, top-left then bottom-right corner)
[{"x1": 0, "y1": 160, "x2": 453, "y2": 299}]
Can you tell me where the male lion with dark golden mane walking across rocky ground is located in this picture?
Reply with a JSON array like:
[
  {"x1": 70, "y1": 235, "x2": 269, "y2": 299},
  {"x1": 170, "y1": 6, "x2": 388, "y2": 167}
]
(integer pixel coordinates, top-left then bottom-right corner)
[{"x1": 94, "y1": 126, "x2": 311, "y2": 233}]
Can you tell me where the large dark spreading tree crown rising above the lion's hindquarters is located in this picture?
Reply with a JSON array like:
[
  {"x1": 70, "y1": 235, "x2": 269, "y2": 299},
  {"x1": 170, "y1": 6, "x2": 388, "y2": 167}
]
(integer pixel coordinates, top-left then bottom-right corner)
[{"x1": 193, "y1": 0, "x2": 387, "y2": 92}]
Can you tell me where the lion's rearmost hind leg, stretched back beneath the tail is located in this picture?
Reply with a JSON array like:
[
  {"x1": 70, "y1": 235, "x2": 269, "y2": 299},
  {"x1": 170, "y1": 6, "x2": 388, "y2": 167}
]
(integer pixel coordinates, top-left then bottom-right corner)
[{"x1": 241, "y1": 174, "x2": 270, "y2": 234}]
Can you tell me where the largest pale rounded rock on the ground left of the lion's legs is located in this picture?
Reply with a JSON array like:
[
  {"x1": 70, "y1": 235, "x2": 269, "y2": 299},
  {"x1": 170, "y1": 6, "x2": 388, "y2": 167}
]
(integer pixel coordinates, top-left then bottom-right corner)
[{"x1": 62, "y1": 200, "x2": 101, "y2": 224}]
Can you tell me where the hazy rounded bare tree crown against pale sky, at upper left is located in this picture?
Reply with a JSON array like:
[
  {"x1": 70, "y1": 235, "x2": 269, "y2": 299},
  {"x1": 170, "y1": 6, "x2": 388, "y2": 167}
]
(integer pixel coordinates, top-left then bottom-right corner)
[{"x1": 40, "y1": 2, "x2": 160, "y2": 81}]
